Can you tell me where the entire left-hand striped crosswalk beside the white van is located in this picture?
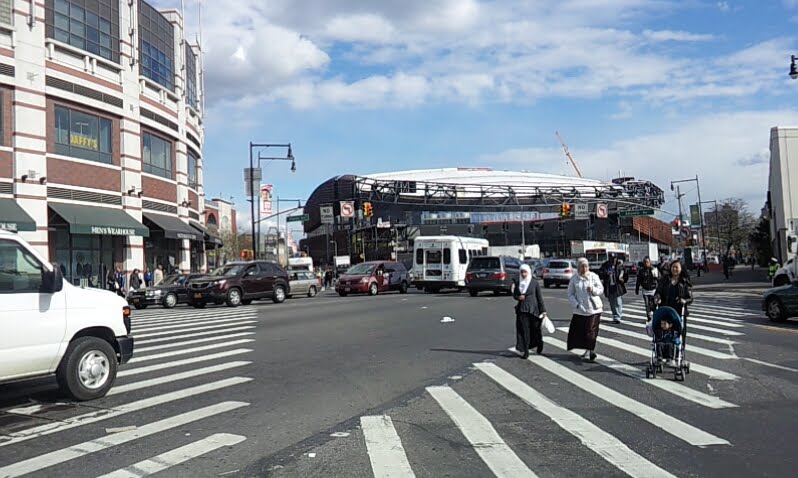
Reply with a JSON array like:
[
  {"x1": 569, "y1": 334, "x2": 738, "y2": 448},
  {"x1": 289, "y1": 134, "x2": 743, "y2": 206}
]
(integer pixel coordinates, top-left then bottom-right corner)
[{"x1": 0, "y1": 308, "x2": 258, "y2": 478}]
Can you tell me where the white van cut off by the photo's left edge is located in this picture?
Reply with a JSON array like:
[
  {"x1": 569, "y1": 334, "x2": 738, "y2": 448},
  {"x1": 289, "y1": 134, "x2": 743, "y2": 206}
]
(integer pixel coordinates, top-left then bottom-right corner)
[{"x1": 0, "y1": 230, "x2": 133, "y2": 400}]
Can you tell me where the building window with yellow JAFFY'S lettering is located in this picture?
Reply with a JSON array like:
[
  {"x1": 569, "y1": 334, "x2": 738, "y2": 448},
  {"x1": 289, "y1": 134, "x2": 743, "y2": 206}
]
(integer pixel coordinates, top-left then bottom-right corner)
[{"x1": 55, "y1": 106, "x2": 113, "y2": 164}]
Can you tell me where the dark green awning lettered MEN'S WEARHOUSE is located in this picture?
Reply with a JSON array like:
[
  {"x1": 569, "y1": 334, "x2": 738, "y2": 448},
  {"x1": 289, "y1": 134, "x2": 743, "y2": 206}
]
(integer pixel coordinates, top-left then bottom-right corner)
[{"x1": 49, "y1": 202, "x2": 150, "y2": 237}]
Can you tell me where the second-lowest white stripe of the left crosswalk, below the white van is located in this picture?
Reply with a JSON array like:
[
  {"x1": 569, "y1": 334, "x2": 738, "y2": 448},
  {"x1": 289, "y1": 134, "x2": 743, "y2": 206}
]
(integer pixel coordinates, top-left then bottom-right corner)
[{"x1": 0, "y1": 402, "x2": 249, "y2": 478}]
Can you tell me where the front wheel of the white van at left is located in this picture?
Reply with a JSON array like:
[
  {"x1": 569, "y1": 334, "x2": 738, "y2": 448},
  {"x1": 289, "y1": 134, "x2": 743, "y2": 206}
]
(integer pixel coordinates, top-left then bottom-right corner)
[{"x1": 56, "y1": 337, "x2": 117, "y2": 401}]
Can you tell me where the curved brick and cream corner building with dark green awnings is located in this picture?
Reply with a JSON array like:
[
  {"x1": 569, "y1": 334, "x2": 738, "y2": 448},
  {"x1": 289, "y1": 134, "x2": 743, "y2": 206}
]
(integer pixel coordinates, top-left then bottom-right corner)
[{"x1": 0, "y1": 0, "x2": 215, "y2": 287}]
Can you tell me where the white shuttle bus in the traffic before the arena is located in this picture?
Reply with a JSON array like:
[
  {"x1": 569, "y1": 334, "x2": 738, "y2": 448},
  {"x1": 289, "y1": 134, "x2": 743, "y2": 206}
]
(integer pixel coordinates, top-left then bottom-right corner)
[{"x1": 412, "y1": 236, "x2": 489, "y2": 292}]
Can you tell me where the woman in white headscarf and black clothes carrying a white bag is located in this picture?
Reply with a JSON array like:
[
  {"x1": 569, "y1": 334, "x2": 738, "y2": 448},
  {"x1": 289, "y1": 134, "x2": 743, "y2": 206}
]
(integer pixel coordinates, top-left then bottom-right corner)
[{"x1": 513, "y1": 264, "x2": 546, "y2": 359}]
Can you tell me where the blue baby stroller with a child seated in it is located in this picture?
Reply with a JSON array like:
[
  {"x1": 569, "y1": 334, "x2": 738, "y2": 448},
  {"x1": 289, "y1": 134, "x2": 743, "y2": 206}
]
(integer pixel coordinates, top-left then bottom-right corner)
[{"x1": 646, "y1": 307, "x2": 690, "y2": 382}]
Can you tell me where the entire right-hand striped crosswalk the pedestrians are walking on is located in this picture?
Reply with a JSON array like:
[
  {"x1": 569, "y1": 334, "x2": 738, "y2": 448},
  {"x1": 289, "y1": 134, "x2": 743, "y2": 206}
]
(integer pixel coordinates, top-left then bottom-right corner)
[{"x1": 319, "y1": 293, "x2": 776, "y2": 477}]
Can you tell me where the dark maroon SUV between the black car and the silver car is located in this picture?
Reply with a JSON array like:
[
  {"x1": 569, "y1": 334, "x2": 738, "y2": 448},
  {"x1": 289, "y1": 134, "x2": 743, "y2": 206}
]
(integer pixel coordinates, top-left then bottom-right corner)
[{"x1": 189, "y1": 261, "x2": 291, "y2": 309}]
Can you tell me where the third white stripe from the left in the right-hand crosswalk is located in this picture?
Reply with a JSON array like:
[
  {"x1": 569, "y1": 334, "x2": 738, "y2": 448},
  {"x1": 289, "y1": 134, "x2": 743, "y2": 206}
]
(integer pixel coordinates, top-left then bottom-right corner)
[{"x1": 474, "y1": 363, "x2": 674, "y2": 478}]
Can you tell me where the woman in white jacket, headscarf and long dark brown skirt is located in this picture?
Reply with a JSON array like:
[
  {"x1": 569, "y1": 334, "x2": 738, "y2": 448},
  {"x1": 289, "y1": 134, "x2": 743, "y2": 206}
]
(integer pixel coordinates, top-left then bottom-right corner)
[{"x1": 568, "y1": 257, "x2": 604, "y2": 362}]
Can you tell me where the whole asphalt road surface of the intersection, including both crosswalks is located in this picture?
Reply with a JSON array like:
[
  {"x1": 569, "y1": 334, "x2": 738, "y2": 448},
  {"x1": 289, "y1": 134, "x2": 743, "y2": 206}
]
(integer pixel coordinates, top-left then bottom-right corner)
[{"x1": 0, "y1": 282, "x2": 798, "y2": 477}]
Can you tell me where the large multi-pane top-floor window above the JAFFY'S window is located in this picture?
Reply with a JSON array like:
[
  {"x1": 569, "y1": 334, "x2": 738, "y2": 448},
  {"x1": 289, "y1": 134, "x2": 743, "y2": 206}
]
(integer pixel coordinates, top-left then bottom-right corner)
[{"x1": 45, "y1": 0, "x2": 119, "y2": 63}]
